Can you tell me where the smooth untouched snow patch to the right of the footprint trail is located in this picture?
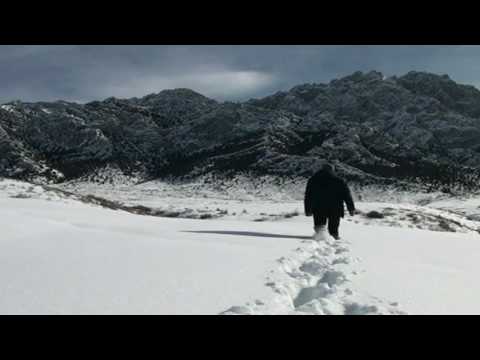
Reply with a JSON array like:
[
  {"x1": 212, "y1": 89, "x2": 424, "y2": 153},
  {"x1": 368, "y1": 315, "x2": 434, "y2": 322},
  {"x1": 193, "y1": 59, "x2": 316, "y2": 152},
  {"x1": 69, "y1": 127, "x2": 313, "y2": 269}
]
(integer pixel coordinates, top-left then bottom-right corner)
[{"x1": 345, "y1": 226, "x2": 480, "y2": 314}]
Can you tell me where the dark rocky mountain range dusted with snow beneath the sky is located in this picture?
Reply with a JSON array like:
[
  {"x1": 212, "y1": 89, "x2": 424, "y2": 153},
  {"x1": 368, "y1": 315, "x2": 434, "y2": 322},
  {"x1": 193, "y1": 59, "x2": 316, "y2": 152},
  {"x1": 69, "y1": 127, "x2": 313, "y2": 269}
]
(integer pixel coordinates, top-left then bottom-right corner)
[{"x1": 0, "y1": 71, "x2": 480, "y2": 189}]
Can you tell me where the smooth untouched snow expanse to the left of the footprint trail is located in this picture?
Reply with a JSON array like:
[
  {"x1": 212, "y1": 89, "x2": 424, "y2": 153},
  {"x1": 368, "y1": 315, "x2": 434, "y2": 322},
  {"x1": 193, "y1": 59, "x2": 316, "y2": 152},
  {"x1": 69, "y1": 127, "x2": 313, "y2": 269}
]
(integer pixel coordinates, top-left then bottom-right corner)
[{"x1": 0, "y1": 195, "x2": 299, "y2": 314}]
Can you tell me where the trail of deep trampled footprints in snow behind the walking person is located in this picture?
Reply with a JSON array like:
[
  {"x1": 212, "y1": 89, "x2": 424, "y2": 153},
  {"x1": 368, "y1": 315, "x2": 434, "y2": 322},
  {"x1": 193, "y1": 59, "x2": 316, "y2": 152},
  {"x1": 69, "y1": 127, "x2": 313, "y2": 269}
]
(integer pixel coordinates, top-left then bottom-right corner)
[{"x1": 222, "y1": 232, "x2": 406, "y2": 315}]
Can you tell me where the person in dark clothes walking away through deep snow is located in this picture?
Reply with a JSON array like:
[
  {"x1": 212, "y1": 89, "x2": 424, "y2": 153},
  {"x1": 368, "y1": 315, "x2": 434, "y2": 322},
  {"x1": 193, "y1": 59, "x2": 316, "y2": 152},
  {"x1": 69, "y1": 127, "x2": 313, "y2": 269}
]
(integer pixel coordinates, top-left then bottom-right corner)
[{"x1": 305, "y1": 164, "x2": 355, "y2": 240}]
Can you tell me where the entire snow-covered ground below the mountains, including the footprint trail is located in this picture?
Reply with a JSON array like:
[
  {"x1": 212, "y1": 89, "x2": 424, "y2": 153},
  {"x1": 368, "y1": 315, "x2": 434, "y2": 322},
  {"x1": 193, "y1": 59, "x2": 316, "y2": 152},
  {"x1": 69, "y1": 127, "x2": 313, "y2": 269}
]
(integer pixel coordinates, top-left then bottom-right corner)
[{"x1": 0, "y1": 180, "x2": 480, "y2": 314}]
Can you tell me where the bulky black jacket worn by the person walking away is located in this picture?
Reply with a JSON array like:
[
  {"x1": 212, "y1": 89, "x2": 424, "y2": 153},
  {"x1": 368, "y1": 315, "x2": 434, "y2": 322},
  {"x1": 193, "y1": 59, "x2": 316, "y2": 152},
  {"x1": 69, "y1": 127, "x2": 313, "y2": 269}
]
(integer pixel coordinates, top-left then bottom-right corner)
[{"x1": 305, "y1": 170, "x2": 355, "y2": 217}]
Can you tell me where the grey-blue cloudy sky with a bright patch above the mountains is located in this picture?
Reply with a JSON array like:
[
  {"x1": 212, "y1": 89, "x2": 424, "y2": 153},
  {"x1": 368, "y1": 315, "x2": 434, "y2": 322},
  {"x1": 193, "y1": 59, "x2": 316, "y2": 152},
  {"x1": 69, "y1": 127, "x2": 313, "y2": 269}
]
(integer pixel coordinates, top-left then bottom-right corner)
[{"x1": 0, "y1": 45, "x2": 480, "y2": 103}]
